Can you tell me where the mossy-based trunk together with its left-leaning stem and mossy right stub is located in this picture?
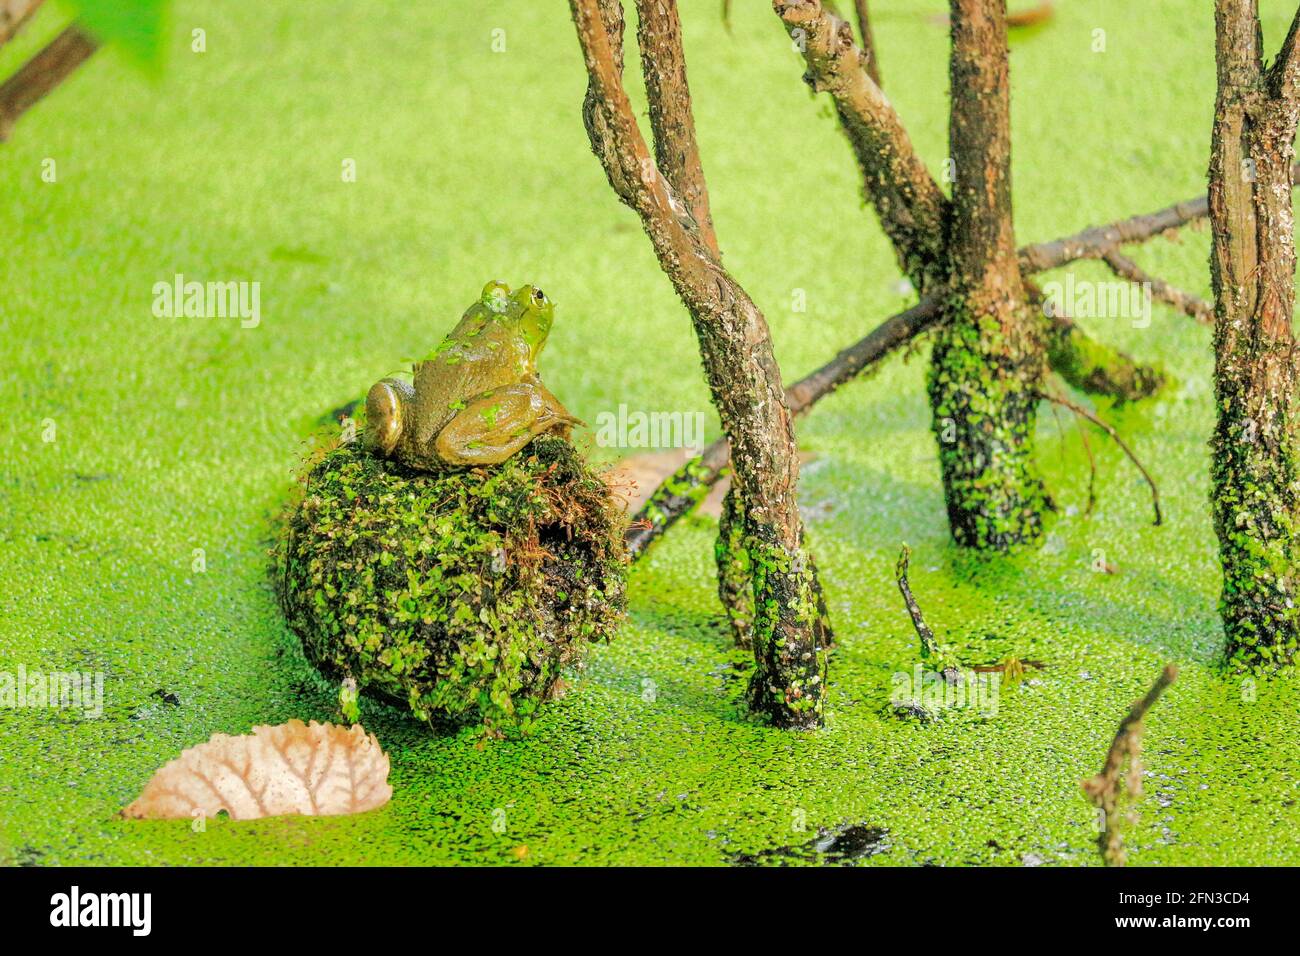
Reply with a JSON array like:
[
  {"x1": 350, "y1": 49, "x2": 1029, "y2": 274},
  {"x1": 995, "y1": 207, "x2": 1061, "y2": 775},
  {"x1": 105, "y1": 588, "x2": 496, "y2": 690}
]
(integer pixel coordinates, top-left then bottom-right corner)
[{"x1": 774, "y1": 0, "x2": 1162, "y2": 550}]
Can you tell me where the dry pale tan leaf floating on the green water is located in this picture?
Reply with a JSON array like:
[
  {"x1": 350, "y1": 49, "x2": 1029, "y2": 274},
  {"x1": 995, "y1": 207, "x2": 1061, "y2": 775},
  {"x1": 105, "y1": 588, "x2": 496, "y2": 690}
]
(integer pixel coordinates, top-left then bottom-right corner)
[{"x1": 122, "y1": 721, "x2": 393, "y2": 819}]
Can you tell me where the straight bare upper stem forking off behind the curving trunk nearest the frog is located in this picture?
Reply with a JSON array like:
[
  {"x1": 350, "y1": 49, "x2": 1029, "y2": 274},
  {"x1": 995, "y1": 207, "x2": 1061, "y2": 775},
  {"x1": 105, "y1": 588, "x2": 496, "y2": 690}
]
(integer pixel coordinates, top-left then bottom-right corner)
[{"x1": 637, "y1": 0, "x2": 718, "y2": 256}]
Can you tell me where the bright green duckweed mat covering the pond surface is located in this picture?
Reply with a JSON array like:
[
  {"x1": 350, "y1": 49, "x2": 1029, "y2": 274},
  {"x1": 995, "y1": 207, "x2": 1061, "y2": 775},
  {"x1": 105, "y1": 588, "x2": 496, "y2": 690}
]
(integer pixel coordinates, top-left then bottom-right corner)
[{"x1": 0, "y1": 0, "x2": 1300, "y2": 865}]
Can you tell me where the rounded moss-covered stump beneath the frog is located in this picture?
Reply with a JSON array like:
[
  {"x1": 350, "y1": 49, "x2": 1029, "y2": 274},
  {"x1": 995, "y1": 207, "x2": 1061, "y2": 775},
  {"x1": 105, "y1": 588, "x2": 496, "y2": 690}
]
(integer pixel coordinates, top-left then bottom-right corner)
[{"x1": 277, "y1": 436, "x2": 627, "y2": 736}]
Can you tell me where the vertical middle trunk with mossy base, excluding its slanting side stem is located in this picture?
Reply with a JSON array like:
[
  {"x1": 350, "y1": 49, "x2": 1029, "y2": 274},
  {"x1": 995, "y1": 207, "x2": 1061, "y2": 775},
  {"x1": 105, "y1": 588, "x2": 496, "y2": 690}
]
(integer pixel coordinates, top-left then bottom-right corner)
[{"x1": 930, "y1": 0, "x2": 1049, "y2": 551}]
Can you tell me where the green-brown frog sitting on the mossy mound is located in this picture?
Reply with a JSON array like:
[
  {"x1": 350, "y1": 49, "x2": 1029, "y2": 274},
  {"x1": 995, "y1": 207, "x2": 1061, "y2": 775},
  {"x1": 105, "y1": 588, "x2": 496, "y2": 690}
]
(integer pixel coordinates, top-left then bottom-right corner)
[{"x1": 364, "y1": 280, "x2": 582, "y2": 471}]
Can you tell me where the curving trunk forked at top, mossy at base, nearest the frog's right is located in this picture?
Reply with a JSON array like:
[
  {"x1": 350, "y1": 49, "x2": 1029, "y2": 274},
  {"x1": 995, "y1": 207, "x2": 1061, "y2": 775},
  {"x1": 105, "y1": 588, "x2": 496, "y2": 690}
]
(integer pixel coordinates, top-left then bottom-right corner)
[{"x1": 571, "y1": 0, "x2": 826, "y2": 727}]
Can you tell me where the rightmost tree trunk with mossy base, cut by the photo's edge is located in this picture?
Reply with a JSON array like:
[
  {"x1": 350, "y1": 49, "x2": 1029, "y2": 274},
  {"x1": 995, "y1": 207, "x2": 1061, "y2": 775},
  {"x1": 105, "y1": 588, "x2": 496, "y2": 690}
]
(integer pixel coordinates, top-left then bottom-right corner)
[{"x1": 1209, "y1": 0, "x2": 1300, "y2": 670}]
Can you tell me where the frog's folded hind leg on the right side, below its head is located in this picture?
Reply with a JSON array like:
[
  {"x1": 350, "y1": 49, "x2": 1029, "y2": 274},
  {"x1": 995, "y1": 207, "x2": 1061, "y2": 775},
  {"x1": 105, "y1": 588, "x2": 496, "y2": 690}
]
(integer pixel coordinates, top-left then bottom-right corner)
[{"x1": 434, "y1": 382, "x2": 582, "y2": 466}]
